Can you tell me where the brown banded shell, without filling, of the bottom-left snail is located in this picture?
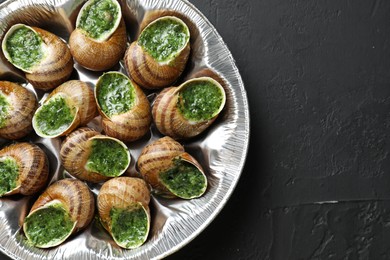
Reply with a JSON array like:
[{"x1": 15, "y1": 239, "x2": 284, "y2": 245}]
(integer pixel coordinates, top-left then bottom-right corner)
[{"x1": 23, "y1": 179, "x2": 95, "y2": 248}]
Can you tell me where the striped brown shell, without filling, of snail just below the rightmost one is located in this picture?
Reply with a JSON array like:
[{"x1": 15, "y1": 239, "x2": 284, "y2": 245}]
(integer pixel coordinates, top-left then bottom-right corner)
[{"x1": 137, "y1": 136, "x2": 207, "y2": 199}]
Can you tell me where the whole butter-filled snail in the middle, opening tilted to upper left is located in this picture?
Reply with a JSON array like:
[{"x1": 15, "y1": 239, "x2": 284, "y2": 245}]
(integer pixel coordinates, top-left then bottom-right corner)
[{"x1": 95, "y1": 72, "x2": 152, "y2": 142}]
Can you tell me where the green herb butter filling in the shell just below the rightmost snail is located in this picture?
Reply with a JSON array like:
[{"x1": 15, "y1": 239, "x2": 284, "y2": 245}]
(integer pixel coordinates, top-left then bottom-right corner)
[{"x1": 160, "y1": 159, "x2": 207, "y2": 199}]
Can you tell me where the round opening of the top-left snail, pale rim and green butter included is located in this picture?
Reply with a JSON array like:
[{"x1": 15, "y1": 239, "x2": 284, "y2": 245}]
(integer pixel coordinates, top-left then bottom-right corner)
[{"x1": 1, "y1": 24, "x2": 46, "y2": 73}]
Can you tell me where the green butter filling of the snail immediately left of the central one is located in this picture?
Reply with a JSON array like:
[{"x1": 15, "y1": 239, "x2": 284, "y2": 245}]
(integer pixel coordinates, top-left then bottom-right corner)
[{"x1": 35, "y1": 95, "x2": 77, "y2": 136}]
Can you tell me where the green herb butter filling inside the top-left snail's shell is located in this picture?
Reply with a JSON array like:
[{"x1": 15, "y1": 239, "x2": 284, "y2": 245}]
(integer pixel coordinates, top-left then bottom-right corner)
[{"x1": 6, "y1": 27, "x2": 44, "y2": 70}]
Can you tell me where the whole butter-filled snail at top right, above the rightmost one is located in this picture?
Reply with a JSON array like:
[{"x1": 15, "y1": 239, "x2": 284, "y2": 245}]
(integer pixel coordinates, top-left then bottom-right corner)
[{"x1": 124, "y1": 16, "x2": 190, "y2": 89}]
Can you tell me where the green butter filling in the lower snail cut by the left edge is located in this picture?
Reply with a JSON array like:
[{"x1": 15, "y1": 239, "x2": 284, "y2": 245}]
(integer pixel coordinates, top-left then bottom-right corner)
[{"x1": 0, "y1": 157, "x2": 19, "y2": 196}]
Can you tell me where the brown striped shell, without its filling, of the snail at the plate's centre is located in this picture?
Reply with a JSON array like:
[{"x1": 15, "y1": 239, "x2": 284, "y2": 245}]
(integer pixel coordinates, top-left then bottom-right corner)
[{"x1": 95, "y1": 72, "x2": 152, "y2": 142}]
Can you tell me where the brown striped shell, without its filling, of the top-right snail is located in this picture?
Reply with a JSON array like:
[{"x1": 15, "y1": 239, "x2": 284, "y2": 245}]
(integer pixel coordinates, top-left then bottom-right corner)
[{"x1": 124, "y1": 16, "x2": 191, "y2": 89}]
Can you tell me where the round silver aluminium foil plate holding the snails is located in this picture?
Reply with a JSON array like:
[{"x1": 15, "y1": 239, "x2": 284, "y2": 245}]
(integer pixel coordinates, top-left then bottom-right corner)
[{"x1": 0, "y1": 0, "x2": 249, "y2": 259}]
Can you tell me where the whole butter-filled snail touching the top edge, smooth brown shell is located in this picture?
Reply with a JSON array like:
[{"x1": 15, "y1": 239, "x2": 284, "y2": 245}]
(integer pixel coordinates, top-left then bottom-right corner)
[{"x1": 69, "y1": 0, "x2": 127, "y2": 71}]
